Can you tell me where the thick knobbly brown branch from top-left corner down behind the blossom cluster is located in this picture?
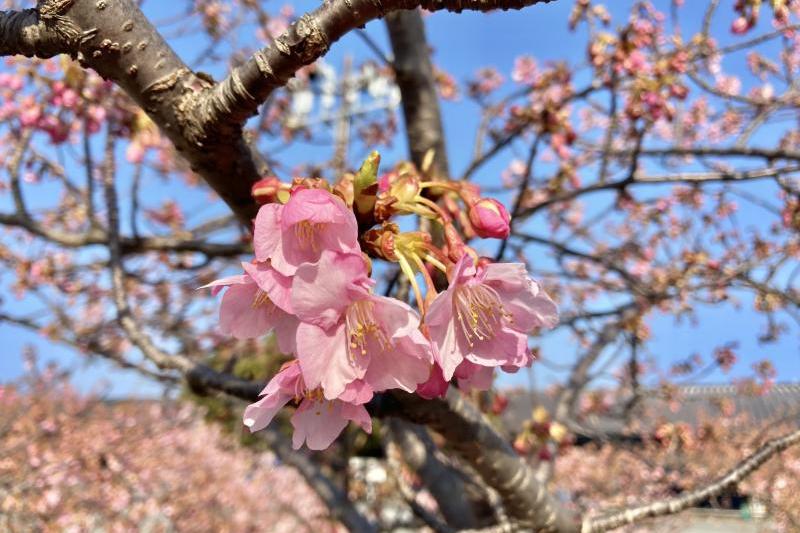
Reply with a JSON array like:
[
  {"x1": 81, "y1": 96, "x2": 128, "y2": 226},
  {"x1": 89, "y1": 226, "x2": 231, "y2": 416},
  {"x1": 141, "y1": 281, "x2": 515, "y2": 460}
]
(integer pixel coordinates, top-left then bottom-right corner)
[{"x1": 0, "y1": 0, "x2": 258, "y2": 226}]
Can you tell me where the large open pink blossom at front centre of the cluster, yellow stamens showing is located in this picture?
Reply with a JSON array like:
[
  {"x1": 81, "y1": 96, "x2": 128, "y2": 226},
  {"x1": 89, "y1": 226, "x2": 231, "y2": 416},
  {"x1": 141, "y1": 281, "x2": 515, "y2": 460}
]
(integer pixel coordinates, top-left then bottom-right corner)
[{"x1": 292, "y1": 251, "x2": 433, "y2": 399}]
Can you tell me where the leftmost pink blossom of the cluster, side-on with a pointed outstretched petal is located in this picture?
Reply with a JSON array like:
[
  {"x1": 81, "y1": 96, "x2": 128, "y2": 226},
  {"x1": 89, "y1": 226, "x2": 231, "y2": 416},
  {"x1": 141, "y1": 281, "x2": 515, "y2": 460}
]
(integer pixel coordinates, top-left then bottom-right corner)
[{"x1": 201, "y1": 263, "x2": 298, "y2": 353}]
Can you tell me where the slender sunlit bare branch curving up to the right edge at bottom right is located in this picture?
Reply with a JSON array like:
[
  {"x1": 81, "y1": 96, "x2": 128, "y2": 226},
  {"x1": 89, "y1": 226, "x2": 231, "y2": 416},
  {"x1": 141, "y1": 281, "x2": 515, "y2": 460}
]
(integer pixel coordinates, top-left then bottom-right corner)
[{"x1": 581, "y1": 430, "x2": 800, "y2": 533}]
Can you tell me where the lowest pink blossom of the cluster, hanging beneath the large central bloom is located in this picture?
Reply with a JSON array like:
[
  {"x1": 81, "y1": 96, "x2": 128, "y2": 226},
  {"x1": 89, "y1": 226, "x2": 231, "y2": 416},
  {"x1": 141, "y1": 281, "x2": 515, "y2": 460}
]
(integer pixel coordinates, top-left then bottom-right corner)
[{"x1": 244, "y1": 361, "x2": 372, "y2": 450}]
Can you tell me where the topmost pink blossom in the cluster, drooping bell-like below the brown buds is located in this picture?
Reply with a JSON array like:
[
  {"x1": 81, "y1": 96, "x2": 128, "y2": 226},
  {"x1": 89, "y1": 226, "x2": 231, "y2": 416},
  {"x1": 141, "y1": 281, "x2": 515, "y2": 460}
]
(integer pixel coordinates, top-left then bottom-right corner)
[{"x1": 253, "y1": 189, "x2": 360, "y2": 276}]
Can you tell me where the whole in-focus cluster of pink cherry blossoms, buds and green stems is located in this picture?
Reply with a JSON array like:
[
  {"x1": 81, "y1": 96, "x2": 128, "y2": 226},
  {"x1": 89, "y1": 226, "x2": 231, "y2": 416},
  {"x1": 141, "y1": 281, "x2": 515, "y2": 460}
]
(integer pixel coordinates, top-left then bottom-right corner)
[{"x1": 207, "y1": 154, "x2": 557, "y2": 450}]
